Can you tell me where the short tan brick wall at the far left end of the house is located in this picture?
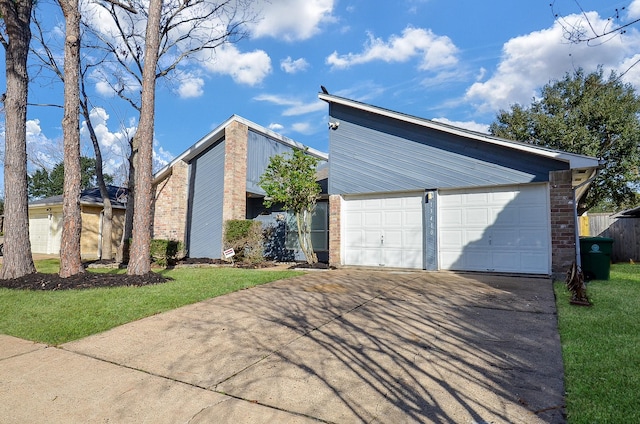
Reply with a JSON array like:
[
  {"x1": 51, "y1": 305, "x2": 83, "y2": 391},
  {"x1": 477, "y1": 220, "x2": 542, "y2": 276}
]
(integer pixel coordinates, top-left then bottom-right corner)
[{"x1": 152, "y1": 161, "x2": 189, "y2": 243}]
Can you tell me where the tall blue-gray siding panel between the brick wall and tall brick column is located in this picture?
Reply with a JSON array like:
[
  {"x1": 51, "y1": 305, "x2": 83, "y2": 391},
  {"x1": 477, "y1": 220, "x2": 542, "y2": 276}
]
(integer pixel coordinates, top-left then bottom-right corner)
[{"x1": 187, "y1": 140, "x2": 224, "y2": 259}]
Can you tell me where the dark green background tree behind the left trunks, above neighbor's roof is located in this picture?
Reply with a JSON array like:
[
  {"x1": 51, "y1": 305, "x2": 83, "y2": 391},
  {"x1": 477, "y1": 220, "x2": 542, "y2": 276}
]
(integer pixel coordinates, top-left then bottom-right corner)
[{"x1": 29, "y1": 156, "x2": 113, "y2": 199}]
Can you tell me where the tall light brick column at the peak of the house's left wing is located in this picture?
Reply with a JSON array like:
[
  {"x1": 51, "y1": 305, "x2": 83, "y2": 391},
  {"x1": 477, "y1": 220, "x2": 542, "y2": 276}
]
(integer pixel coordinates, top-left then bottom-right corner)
[{"x1": 222, "y1": 121, "x2": 249, "y2": 222}]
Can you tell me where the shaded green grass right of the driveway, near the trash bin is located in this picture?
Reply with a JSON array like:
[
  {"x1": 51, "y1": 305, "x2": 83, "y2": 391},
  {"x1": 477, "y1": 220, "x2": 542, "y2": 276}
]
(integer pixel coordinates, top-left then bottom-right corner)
[{"x1": 555, "y1": 264, "x2": 640, "y2": 424}]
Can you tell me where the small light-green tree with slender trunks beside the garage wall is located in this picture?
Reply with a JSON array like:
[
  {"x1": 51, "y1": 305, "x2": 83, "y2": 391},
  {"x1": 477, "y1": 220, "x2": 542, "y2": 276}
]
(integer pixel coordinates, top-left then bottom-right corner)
[{"x1": 260, "y1": 150, "x2": 320, "y2": 264}]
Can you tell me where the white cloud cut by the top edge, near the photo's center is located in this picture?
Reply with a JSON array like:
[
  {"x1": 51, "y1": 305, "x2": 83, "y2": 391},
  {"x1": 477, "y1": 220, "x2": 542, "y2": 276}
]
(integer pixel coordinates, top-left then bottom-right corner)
[{"x1": 251, "y1": 0, "x2": 335, "y2": 41}]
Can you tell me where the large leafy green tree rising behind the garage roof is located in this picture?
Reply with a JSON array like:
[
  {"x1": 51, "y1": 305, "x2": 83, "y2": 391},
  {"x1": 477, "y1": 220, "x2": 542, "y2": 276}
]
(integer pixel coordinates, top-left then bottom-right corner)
[{"x1": 489, "y1": 68, "x2": 640, "y2": 212}]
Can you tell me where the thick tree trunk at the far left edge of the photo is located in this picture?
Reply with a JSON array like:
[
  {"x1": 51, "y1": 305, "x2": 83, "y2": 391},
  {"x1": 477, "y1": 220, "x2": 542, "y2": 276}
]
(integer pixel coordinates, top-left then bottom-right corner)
[{"x1": 0, "y1": 0, "x2": 36, "y2": 279}]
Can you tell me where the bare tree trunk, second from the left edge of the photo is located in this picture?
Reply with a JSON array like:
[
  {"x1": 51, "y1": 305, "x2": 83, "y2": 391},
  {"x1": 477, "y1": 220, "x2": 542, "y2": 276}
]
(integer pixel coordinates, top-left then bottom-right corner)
[{"x1": 59, "y1": 0, "x2": 84, "y2": 278}]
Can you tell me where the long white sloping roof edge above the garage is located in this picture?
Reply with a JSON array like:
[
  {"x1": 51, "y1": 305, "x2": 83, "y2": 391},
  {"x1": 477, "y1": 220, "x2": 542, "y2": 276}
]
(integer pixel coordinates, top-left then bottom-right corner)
[{"x1": 318, "y1": 93, "x2": 601, "y2": 169}]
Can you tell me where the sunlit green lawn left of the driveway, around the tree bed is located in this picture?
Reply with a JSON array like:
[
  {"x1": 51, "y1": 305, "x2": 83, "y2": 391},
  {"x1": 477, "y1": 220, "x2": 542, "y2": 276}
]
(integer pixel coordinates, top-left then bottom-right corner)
[{"x1": 0, "y1": 260, "x2": 301, "y2": 345}]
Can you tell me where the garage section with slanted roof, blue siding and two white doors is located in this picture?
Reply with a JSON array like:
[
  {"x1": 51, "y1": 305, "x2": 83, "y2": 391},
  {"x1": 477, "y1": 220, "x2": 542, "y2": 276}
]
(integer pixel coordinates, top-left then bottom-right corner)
[{"x1": 319, "y1": 93, "x2": 598, "y2": 275}]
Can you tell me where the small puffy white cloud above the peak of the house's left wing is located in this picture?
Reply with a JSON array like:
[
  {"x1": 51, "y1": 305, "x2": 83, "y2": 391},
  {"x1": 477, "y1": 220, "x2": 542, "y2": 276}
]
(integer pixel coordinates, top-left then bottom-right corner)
[{"x1": 205, "y1": 45, "x2": 271, "y2": 86}]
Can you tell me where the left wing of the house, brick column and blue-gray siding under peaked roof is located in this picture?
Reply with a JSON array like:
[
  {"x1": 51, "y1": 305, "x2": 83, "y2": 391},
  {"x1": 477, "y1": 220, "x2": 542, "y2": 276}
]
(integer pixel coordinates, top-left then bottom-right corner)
[{"x1": 153, "y1": 115, "x2": 328, "y2": 259}]
